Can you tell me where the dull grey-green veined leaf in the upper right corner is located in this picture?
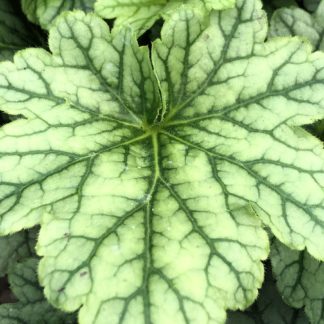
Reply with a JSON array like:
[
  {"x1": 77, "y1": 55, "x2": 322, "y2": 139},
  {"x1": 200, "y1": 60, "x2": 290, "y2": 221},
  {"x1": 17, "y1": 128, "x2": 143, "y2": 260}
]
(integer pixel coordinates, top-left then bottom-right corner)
[{"x1": 269, "y1": 1, "x2": 324, "y2": 50}]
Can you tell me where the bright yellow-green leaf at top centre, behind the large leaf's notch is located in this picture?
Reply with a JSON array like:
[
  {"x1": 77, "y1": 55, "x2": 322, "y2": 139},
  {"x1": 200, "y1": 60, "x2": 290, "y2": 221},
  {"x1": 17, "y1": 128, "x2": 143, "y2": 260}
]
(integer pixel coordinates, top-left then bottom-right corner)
[{"x1": 95, "y1": 0, "x2": 235, "y2": 35}]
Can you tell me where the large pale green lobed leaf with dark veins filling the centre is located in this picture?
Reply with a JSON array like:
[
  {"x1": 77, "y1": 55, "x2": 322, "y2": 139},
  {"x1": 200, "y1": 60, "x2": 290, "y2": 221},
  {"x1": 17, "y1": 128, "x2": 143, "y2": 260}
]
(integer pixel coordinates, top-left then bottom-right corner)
[{"x1": 0, "y1": 0, "x2": 324, "y2": 324}]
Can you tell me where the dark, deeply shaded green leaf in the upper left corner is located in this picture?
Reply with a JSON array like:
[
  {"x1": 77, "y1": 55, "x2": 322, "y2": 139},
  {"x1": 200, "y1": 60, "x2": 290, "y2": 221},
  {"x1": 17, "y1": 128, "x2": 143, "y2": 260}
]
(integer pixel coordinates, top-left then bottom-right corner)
[{"x1": 0, "y1": 0, "x2": 38, "y2": 61}]
